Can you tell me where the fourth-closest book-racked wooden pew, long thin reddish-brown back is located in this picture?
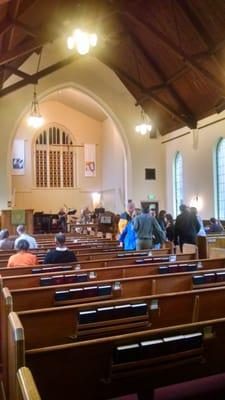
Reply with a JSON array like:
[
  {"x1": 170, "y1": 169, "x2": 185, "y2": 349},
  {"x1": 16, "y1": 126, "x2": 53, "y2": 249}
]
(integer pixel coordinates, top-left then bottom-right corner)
[{"x1": 1, "y1": 259, "x2": 225, "y2": 293}]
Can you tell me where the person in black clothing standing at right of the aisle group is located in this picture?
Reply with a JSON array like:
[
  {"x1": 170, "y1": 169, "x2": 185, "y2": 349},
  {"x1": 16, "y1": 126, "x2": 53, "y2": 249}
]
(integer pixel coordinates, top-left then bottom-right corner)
[{"x1": 174, "y1": 204, "x2": 201, "y2": 251}]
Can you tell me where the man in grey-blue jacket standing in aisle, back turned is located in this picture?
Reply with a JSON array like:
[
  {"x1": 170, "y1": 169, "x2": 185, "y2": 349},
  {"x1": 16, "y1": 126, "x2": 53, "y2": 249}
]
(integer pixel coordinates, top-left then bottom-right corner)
[{"x1": 134, "y1": 206, "x2": 166, "y2": 250}]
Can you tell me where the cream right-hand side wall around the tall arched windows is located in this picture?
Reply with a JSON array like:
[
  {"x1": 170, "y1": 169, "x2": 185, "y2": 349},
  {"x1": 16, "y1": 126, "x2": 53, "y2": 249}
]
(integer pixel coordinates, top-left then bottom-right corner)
[{"x1": 162, "y1": 113, "x2": 225, "y2": 219}]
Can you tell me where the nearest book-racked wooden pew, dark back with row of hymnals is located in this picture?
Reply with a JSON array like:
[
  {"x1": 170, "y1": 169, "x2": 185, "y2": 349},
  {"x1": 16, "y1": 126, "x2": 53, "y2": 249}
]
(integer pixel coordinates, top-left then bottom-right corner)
[{"x1": 9, "y1": 313, "x2": 225, "y2": 400}]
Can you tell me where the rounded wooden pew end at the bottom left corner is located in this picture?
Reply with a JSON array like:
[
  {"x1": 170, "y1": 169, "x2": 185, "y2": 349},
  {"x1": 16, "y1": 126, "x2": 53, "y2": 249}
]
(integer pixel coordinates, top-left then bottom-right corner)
[{"x1": 17, "y1": 367, "x2": 41, "y2": 400}]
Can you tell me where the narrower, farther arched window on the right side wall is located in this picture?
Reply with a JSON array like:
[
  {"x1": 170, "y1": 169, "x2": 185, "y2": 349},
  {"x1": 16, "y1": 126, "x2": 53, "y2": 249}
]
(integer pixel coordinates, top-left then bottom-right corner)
[{"x1": 174, "y1": 152, "x2": 184, "y2": 215}]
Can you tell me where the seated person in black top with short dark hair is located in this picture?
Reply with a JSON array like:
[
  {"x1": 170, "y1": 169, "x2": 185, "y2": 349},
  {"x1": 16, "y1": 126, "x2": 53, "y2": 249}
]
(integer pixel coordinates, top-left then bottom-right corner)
[{"x1": 44, "y1": 233, "x2": 77, "y2": 264}]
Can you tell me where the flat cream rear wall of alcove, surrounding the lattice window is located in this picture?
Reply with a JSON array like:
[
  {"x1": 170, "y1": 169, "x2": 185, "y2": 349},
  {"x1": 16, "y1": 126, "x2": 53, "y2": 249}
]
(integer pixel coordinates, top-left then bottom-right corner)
[{"x1": 12, "y1": 101, "x2": 102, "y2": 212}]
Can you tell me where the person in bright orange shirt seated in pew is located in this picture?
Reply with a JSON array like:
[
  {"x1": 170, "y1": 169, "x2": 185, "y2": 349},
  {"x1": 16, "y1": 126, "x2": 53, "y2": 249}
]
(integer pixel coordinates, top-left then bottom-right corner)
[{"x1": 7, "y1": 239, "x2": 38, "y2": 268}]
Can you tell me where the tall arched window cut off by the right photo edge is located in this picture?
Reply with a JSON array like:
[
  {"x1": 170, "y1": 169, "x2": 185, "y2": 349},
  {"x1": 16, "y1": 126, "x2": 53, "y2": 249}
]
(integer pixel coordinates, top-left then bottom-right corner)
[{"x1": 216, "y1": 139, "x2": 225, "y2": 219}]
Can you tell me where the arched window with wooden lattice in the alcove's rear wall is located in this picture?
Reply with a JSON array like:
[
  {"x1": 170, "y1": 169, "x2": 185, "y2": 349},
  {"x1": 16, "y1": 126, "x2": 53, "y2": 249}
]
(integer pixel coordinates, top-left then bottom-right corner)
[{"x1": 35, "y1": 126, "x2": 75, "y2": 188}]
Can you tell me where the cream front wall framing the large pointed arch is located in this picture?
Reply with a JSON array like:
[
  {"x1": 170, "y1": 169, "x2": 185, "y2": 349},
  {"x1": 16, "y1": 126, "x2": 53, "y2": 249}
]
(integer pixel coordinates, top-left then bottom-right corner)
[{"x1": 0, "y1": 45, "x2": 164, "y2": 214}]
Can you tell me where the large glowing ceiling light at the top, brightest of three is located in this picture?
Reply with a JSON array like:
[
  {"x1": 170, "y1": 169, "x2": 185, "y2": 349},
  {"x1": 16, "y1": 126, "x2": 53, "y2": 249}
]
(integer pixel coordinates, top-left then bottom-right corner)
[{"x1": 67, "y1": 29, "x2": 98, "y2": 55}]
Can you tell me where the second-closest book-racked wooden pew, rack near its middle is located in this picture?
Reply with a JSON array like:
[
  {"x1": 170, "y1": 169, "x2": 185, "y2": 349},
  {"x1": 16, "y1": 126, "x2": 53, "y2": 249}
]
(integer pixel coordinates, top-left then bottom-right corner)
[{"x1": 2, "y1": 278, "x2": 225, "y2": 347}]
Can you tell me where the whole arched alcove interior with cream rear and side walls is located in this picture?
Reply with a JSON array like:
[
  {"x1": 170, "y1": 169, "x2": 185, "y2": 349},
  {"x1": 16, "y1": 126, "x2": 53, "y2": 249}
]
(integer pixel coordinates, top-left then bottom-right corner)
[{"x1": 10, "y1": 83, "x2": 131, "y2": 216}]
